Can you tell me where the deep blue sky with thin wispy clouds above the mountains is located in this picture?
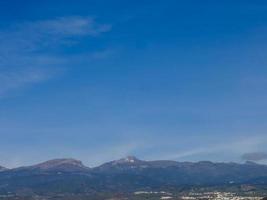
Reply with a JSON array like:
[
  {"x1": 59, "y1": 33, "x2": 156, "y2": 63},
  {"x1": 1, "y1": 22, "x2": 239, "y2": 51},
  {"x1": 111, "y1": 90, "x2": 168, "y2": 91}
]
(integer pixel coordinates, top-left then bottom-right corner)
[{"x1": 0, "y1": 0, "x2": 267, "y2": 167}]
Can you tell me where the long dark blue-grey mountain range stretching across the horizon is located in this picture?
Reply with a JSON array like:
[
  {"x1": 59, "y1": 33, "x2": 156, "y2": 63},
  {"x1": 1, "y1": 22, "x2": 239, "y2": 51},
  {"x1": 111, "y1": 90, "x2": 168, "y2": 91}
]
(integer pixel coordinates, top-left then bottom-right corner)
[{"x1": 0, "y1": 156, "x2": 267, "y2": 194}]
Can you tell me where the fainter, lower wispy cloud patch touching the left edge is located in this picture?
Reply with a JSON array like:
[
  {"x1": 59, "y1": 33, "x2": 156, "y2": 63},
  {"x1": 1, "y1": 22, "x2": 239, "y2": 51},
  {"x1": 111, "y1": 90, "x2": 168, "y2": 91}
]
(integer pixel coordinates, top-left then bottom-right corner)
[{"x1": 0, "y1": 54, "x2": 65, "y2": 98}]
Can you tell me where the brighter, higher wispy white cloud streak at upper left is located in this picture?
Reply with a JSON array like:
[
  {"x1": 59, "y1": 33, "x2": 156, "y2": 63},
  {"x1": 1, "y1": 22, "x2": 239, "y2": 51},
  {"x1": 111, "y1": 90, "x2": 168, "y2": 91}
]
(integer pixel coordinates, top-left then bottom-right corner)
[{"x1": 0, "y1": 16, "x2": 112, "y2": 53}]
